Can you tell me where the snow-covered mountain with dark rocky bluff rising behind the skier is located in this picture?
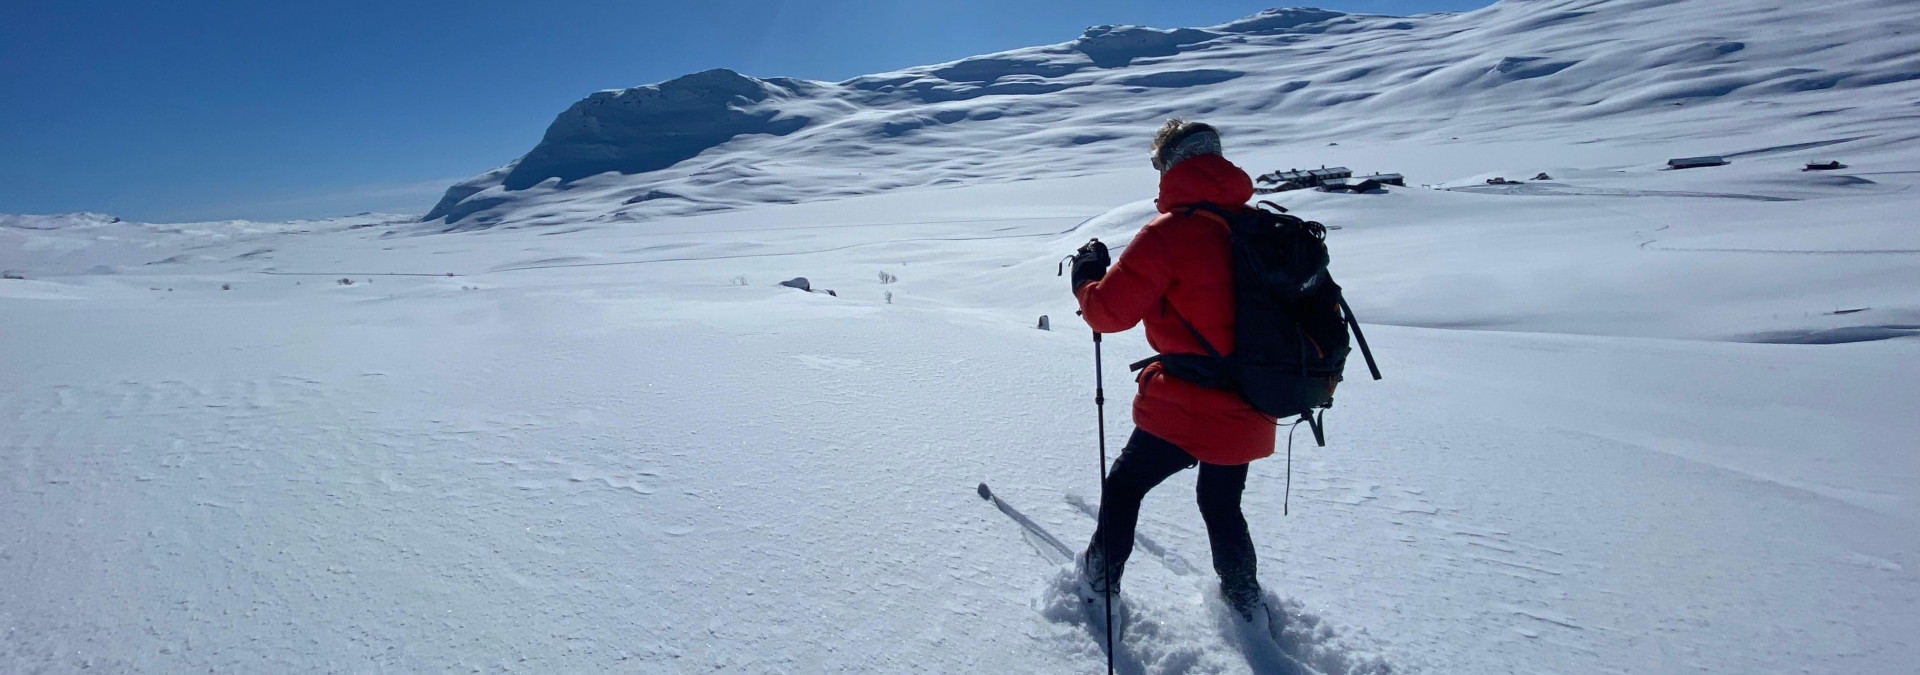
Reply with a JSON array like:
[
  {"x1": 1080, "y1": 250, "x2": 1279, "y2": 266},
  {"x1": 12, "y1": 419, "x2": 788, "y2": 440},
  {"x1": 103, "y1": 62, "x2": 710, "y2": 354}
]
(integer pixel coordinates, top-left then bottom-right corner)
[{"x1": 426, "y1": 0, "x2": 1920, "y2": 228}]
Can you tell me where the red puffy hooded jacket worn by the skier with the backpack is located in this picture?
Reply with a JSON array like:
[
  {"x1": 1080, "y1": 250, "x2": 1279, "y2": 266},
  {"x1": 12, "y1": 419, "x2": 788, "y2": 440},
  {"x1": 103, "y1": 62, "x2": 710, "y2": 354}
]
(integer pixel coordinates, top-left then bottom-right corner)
[{"x1": 1073, "y1": 155, "x2": 1275, "y2": 464}]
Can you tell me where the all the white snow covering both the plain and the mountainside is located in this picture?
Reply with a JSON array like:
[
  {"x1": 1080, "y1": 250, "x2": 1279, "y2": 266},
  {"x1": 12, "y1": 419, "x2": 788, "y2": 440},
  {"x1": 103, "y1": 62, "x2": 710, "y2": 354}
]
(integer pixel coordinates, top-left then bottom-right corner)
[{"x1": 0, "y1": 2, "x2": 1920, "y2": 673}]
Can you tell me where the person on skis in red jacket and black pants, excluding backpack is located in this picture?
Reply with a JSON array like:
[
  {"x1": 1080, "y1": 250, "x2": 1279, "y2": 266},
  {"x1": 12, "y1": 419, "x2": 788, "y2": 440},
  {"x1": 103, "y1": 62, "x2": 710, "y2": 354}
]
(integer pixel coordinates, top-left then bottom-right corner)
[{"x1": 1071, "y1": 119, "x2": 1277, "y2": 621}]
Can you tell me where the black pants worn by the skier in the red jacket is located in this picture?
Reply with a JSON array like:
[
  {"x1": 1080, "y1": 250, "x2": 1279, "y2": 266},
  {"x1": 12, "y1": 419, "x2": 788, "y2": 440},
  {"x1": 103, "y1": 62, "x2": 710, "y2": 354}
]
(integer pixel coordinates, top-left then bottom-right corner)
[{"x1": 1087, "y1": 430, "x2": 1260, "y2": 598}]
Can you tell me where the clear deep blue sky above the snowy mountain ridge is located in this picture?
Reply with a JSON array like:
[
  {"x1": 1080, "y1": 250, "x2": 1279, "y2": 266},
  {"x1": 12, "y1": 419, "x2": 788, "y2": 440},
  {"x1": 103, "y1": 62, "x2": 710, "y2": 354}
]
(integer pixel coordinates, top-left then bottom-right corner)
[{"x1": 0, "y1": 0, "x2": 1490, "y2": 222}]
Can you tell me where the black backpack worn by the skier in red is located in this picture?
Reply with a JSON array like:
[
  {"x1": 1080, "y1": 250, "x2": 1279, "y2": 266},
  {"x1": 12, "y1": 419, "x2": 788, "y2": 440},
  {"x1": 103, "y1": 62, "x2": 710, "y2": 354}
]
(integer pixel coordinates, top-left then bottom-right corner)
[{"x1": 1133, "y1": 201, "x2": 1380, "y2": 445}]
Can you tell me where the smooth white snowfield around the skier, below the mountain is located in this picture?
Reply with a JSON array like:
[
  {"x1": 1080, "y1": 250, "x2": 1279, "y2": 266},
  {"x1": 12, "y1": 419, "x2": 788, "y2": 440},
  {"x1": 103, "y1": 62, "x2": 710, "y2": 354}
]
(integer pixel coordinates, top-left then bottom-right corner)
[{"x1": 0, "y1": 162, "x2": 1920, "y2": 673}]
